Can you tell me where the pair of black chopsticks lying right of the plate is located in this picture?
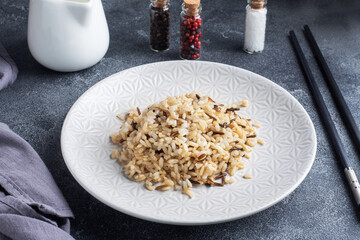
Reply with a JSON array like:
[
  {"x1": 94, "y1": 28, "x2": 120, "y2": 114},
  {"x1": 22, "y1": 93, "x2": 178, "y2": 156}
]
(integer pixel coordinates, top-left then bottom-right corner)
[{"x1": 289, "y1": 25, "x2": 360, "y2": 206}]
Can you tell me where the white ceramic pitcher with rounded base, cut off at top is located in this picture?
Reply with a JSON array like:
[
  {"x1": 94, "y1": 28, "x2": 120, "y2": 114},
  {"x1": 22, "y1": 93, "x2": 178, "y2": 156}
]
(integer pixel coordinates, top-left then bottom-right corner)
[{"x1": 28, "y1": 0, "x2": 109, "y2": 72}]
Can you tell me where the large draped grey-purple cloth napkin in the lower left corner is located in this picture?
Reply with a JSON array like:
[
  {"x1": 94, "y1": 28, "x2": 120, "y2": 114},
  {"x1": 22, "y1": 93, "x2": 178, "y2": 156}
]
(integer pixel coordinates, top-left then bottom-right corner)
[{"x1": 0, "y1": 123, "x2": 73, "y2": 240}]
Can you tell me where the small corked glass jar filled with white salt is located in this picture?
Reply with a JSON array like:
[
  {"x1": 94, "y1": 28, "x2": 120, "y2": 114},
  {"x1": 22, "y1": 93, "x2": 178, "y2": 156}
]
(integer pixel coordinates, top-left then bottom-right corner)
[{"x1": 244, "y1": 0, "x2": 267, "y2": 54}]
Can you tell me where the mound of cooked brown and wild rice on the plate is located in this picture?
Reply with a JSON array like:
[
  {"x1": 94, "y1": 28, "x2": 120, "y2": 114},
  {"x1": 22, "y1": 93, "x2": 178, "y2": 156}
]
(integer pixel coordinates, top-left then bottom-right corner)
[{"x1": 111, "y1": 92, "x2": 264, "y2": 197}]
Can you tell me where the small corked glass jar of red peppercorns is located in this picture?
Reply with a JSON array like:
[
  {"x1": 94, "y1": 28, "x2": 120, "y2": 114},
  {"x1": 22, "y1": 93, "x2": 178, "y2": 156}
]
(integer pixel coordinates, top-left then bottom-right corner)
[{"x1": 180, "y1": 0, "x2": 202, "y2": 60}]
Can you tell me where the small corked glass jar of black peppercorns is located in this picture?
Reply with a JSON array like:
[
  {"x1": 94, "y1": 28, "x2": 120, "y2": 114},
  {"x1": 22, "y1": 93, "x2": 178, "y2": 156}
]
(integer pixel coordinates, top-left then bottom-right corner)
[{"x1": 149, "y1": 0, "x2": 170, "y2": 52}]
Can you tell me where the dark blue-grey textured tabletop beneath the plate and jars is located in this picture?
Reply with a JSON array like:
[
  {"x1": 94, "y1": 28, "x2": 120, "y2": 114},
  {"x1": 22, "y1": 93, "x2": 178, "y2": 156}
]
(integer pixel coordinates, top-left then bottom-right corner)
[{"x1": 0, "y1": 0, "x2": 360, "y2": 239}]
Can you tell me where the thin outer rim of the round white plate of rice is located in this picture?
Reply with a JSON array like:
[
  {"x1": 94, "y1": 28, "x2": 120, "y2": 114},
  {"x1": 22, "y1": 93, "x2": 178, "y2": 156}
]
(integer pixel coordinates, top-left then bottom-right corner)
[{"x1": 60, "y1": 60, "x2": 317, "y2": 226}]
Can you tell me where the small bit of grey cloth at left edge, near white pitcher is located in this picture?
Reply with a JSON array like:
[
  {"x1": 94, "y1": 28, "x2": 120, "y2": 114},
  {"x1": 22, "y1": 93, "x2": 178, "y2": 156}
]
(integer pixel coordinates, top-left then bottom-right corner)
[{"x1": 0, "y1": 43, "x2": 18, "y2": 90}]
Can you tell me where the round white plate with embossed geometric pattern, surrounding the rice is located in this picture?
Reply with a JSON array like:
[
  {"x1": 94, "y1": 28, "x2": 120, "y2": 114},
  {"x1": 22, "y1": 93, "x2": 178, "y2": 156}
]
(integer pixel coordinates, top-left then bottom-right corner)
[{"x1": 61, "y1": 61, "x2": 316, "y2": 225}]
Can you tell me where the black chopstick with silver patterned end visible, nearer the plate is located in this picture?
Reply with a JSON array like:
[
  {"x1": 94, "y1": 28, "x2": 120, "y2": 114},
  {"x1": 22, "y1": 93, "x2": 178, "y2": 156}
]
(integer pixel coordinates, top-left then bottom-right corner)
[{"x1": 289, "y1": 31, "x2": 360, "y2": 206}]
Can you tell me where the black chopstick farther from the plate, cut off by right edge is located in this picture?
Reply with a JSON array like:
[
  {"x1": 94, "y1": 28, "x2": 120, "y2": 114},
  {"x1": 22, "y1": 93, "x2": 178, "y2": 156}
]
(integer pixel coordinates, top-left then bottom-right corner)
[{"x1": 304, "y1": 25, "x2": 360, "y2": 154}]
